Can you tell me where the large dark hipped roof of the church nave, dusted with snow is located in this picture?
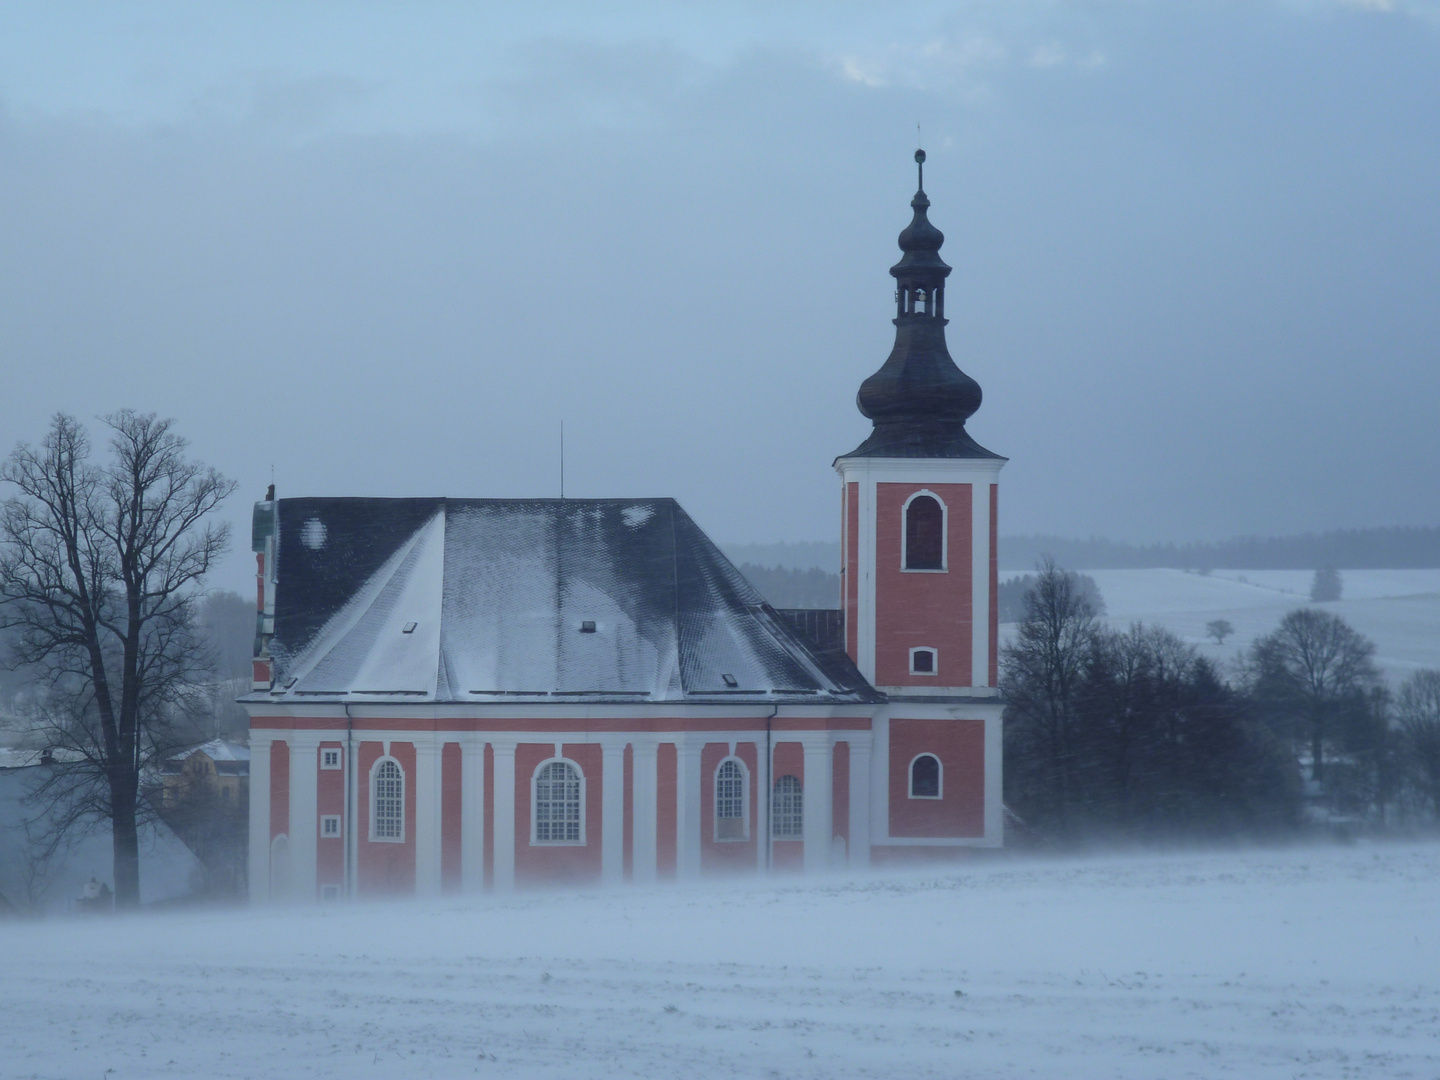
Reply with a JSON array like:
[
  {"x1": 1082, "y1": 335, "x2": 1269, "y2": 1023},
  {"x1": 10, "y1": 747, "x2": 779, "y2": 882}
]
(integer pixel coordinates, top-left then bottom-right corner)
[{"x1": 253, "y1": 498, "x2": 883, "y2": 704}]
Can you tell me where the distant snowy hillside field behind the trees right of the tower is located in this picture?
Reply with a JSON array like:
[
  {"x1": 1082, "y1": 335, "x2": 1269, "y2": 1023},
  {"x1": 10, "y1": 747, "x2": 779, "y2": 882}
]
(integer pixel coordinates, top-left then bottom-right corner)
[{"x1": 1002, "y1": 570, "x2": 1440, "y2": 683}]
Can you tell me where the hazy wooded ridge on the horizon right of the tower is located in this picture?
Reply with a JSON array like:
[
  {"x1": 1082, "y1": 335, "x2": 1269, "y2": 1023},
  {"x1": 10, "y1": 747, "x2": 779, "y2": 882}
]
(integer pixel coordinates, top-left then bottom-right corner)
[{"x1": 999, "y1": 527, "x2": 1440, "y2": 570}]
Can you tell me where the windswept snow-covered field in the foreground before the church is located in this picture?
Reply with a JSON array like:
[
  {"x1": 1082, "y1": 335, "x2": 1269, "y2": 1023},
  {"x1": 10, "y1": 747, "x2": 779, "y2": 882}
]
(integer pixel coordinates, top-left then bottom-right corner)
[{"x1": 0, "y1": 845, "x2": 1440, "y2": 1080}]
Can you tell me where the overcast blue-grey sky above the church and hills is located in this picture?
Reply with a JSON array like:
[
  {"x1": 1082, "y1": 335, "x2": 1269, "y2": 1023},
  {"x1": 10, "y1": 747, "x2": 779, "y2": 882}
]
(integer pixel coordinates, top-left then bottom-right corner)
[{"x1": 0, "y1": 0, "x2": 1440, "y2": 589}]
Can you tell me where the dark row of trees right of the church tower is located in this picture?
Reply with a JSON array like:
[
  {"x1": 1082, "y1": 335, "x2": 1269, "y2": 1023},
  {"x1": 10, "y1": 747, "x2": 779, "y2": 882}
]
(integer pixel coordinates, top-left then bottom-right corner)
[{"x1": 1002, "y1": 563, "x2": 1440, "y2": 845}]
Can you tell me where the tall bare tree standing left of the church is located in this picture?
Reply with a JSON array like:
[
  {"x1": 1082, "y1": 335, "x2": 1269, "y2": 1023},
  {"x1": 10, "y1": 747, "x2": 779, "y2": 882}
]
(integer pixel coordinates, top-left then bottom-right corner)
[{"x1": 0, "y1": 409, "x2": 235, "y2": 907}]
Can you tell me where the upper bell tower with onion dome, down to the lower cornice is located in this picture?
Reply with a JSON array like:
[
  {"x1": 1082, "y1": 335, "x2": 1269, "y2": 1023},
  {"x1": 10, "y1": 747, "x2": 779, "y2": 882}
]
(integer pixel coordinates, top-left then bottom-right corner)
[{"x1": 835, "y1": 150, "x2": 1007, "y2": 698}]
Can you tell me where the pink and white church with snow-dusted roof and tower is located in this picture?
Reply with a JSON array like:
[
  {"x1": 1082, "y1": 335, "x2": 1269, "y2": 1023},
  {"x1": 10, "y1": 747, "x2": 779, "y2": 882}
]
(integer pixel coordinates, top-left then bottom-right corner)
[{"x1": 242, "y1": 151, "x2": 1005, "y2": 901}]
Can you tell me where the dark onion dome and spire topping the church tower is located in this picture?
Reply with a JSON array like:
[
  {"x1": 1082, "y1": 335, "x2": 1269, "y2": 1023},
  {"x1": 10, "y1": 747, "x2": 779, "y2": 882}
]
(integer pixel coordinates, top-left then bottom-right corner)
[{"x1": 845, "y1": 150, "x2": 999, "y2": 458}]
